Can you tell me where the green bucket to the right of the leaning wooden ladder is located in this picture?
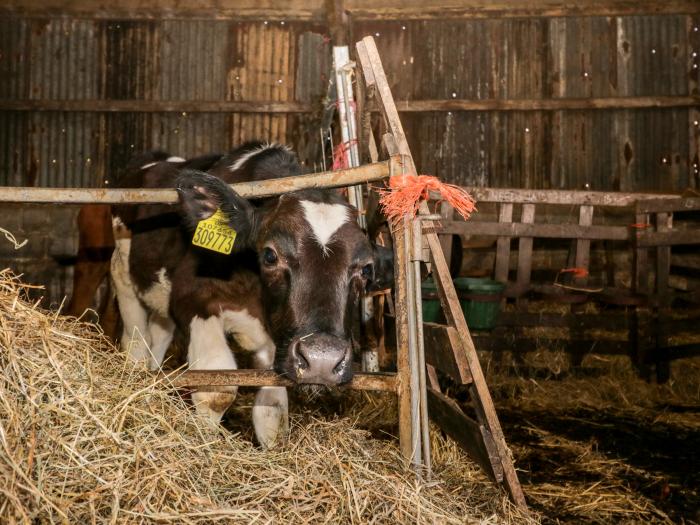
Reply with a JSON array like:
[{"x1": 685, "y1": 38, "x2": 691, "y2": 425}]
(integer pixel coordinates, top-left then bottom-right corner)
[{"x1": 454, "y1": 277, "x2": 505, "y2": 330}]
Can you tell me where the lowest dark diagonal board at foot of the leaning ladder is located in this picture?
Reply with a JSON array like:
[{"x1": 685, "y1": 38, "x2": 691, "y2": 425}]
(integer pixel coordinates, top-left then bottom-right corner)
[{"x1": 428, "y1": 388, "x2": 503, "y2": 483}]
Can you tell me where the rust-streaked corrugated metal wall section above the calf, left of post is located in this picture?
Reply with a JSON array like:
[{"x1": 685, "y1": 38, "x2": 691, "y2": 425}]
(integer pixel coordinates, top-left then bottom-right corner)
[{"x1": 0, "y1": 18, "x2": 330, "y2": 186}]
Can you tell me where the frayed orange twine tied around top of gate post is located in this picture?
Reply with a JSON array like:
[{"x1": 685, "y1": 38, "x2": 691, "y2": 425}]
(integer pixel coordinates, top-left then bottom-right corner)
[{"x1": 379, "y1": 175, "x2": 476, "y2": 225}]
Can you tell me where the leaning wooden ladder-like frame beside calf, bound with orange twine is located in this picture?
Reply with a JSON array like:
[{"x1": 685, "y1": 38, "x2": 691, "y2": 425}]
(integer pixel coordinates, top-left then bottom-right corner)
[{"x1": 356, "y1": 36, "x2": 526, "y2": 507}]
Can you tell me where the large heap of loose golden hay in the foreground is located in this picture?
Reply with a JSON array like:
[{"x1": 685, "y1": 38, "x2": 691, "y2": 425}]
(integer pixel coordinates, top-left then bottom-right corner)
[{"x1": 0, "y1": 271, "x2": 534, "y2": 524}]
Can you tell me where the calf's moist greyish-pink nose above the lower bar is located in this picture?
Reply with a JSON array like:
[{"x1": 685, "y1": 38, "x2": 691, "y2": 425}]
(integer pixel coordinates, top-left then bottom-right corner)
[{"x1": 289, "y1": 333, "x2": 352, "y2": 385}]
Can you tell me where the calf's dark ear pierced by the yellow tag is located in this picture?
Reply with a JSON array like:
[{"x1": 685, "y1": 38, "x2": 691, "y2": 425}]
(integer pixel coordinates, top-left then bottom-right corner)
[{"x1": 176, "y1": 170, "x2": 257, "y2": 251}]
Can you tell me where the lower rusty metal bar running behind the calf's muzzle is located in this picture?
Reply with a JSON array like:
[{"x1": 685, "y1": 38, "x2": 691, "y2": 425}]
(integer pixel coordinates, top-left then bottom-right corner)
[{"x1": 158, "y1": 370, "x2": 396, "y2": 392}]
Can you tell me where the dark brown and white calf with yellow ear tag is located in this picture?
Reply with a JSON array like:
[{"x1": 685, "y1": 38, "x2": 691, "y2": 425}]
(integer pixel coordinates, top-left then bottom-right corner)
[{"x1": 112, "y1": 144, "x2": 391, "y2": 447}]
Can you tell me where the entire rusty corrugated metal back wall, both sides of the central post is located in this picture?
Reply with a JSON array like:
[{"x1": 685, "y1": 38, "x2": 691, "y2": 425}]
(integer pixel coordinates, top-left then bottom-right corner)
[{"x1": 0, "y1": 15, "x2": 700, "y2": 191}]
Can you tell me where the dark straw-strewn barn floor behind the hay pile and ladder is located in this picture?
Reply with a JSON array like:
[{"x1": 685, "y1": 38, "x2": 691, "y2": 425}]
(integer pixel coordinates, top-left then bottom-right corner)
[{"x1": 228, "y1": 352, "x2": 700, "y2": 524}]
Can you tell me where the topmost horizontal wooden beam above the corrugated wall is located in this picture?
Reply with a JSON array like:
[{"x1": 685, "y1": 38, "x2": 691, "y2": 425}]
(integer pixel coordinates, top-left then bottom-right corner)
[{"x1": 5, "y1": 0, "x2": 700, "y2": 23}]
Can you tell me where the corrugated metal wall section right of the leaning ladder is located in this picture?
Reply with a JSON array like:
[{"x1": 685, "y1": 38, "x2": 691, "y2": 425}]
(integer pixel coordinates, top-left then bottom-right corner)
[{"x1": 354, "y1": 16, "x2": 700, "y2": 191}]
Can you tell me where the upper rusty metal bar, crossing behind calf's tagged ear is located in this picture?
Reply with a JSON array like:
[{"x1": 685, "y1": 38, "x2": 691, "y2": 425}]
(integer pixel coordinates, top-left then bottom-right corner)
[{"x1": 0, "y1": 158, "x2": 400, "y2": 204}]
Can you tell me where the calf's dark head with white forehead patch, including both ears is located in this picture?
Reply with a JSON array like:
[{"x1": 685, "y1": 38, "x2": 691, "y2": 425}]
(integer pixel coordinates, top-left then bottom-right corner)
[{"x1": 178, "y1": 171, "x2": 392, "y2": 385}]
